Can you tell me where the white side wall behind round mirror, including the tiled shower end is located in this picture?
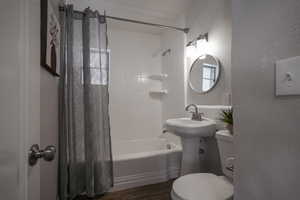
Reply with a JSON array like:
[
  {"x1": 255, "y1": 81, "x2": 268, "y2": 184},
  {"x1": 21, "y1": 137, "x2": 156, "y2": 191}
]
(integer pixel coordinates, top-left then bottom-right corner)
[{"x1": 162, "y1": 0, "x2": 232, "y2": 120}]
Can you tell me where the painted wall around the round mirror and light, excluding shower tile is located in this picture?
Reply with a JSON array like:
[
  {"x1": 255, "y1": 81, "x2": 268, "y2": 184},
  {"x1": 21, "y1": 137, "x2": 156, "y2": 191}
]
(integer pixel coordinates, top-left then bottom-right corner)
[{"x1": 186, "y1": 0, "x2": 231, "y2": 105}]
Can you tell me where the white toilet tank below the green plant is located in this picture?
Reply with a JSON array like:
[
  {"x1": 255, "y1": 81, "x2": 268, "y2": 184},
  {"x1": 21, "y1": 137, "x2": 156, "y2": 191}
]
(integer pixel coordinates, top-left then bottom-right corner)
[{"x1": 216, "y1": 130, "x2": 235, "y2": 180}]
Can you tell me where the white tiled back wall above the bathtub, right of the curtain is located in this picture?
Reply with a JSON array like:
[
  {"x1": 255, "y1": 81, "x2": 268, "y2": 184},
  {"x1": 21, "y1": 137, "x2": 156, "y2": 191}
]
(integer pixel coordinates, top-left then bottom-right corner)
[{"x1": 108, "y1": 28, "x2": 162, "y2": 142}]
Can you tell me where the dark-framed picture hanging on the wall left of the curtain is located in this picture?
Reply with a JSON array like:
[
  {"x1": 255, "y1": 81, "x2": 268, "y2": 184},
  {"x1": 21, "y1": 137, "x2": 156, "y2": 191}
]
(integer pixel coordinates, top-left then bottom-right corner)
[{"x1": 40, "y1": 0, "x2": 61, "y2": 76}]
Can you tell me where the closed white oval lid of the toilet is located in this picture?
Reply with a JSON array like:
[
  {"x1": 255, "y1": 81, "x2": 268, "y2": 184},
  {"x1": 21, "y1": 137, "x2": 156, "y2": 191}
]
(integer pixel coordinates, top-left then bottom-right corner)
[{"x1": 172, "y1": 173, "x2": 233, "y2": 200}]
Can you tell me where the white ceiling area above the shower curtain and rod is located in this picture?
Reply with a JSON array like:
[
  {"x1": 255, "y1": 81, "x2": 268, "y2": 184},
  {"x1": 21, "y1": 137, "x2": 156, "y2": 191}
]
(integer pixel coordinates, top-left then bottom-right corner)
[{"x1": 71, "y1": 0, "x2": 193, "y2": 33}]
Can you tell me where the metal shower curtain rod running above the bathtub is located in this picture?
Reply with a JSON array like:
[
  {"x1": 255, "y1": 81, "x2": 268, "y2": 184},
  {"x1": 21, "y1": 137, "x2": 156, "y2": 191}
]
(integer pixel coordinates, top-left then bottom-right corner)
[{"x1": 59, "y1": 6, "x2": 190, "y2": 33}]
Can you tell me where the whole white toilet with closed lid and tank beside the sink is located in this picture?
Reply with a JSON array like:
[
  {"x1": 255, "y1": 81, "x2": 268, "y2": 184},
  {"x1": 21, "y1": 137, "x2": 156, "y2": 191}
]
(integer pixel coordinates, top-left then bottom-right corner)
[{"x1": 171, "y1": 130, "x2": 234, "y2": 200}]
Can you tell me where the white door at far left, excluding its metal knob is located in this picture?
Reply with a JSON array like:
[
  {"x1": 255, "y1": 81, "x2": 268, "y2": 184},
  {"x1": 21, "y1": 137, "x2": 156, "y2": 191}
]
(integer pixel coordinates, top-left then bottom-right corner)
[{"x1": 0, "y1": 0, "x2": 40, "y2": 200}]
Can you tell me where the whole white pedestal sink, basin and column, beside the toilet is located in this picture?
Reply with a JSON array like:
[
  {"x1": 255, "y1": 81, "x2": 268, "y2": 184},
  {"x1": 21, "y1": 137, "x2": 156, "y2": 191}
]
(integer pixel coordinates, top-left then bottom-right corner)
[{"x1": 165, "y1": 118, "x2": 216, "y2": 175}]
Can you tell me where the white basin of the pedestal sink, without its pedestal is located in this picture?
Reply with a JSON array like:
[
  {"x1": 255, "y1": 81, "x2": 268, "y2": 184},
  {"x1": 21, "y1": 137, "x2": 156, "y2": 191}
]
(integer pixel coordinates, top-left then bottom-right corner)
[{"x1": 165, "y1": 118, "x2": 216, "y2": 137}]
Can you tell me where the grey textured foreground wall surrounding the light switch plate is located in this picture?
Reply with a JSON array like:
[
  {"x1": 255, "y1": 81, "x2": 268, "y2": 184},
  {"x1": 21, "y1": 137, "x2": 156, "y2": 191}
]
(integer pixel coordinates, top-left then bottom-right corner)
[{"x1": 232, "y1": 0, "x2": 300, "y2": 200}]
